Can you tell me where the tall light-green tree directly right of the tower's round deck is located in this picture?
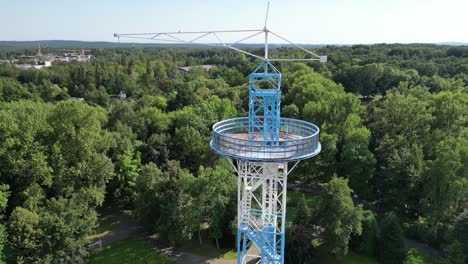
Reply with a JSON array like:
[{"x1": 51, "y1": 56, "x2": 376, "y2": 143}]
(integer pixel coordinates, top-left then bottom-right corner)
[{"x1": 284, "y1": 64, "x2": 375, "y2": 188}]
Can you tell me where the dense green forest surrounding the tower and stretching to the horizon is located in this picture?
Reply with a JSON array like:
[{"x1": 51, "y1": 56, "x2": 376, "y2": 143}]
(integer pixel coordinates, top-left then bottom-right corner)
[{"x1": 0, "y1": 44, "x2": 468, "y2": 264}]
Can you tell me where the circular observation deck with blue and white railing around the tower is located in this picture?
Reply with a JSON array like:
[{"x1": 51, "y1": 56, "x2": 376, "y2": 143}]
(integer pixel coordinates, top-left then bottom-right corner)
[{"x1": 210, "y1": 117, "x2": 321, "y2": 162}]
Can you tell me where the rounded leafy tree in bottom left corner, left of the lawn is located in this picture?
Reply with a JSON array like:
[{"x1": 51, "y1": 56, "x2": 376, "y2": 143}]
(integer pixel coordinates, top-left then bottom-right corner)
[{"x1": 9, "y1": 199, "x2": 96, "y2": 263}]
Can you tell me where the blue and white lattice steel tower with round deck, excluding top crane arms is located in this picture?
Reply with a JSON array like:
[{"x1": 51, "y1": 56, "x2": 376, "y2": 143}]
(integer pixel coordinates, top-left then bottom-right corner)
[{"x1": 210, "y1": 60, "x2": 321, "y2": 264}]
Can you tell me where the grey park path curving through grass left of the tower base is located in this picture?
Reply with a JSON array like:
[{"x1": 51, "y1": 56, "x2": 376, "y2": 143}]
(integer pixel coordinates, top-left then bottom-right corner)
[{"x1": 89, "y1": 211, "x2": 236, "y2": 264}]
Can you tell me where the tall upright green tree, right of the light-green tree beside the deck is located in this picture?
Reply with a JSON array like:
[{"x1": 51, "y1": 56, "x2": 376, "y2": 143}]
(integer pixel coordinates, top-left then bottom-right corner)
[{"x1": 370, "y1": 89, "x2": 433, "y2": 216}]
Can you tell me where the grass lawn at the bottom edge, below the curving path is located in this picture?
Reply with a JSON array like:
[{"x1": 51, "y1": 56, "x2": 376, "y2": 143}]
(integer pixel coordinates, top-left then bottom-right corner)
[{"x1": 89, "y1": 238, "x2": 175, "y2": 264}]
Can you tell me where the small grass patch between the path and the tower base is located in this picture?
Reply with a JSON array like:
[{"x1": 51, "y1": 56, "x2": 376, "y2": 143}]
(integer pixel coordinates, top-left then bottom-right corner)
[{"x1": 177, "y1": 239, "x2": 237, "y2": 259}]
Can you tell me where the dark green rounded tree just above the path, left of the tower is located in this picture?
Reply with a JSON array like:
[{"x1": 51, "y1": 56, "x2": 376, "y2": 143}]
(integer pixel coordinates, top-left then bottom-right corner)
[{"x1": 135, "y1": 162, "x2": 198, "y2": 244}]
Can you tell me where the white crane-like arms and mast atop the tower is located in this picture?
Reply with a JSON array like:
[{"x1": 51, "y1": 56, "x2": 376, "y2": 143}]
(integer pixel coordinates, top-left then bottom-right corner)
[{"x1": 114, "y1": 2, "x2": 327, "y2": 62}]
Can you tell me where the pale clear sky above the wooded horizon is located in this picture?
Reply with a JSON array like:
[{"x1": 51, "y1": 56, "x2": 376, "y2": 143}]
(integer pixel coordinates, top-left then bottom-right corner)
[{"x1": 0, "y1": 0, "x2": 468, "y2": 44}]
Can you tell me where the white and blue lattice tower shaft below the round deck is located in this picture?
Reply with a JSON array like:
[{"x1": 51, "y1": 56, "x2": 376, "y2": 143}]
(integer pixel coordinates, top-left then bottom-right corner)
[{"x1": 237, "y1": 160, "x2": 288, "y2": 264}]
